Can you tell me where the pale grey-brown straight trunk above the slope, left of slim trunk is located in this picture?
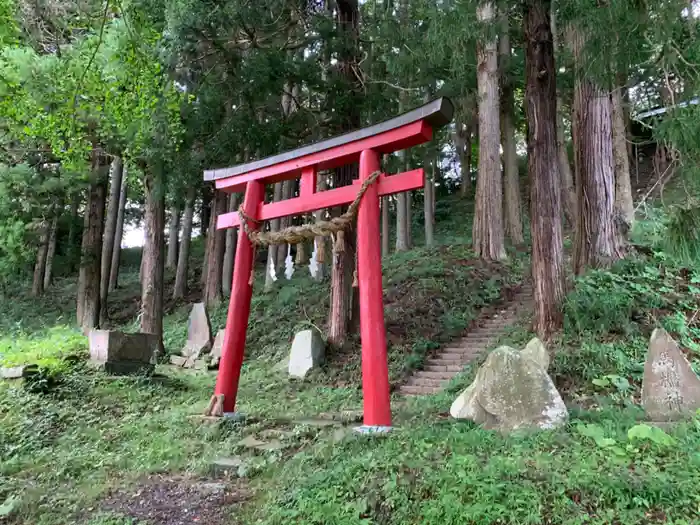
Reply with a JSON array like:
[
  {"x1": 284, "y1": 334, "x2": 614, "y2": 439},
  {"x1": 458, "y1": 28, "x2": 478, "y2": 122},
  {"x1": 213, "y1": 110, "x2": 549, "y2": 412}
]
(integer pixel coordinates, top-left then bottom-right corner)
[{"x1": 472, "y1": 1, "x2": 506, "y2": 261}]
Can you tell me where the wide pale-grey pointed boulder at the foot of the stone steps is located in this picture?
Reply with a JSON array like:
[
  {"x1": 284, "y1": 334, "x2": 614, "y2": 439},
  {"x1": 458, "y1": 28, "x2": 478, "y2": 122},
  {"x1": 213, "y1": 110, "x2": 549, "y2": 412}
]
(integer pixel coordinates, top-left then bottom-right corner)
[{"x1": 450, "y1": 340, "x2": 568, "y2": 432}]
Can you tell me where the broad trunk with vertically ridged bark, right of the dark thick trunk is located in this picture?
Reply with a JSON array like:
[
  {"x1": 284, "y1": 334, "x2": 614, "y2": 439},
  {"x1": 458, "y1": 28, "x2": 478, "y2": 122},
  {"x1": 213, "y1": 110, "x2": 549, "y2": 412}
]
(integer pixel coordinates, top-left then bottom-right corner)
[{"x1": 571, "y1": 29, "x2": 623, "y2": 274}]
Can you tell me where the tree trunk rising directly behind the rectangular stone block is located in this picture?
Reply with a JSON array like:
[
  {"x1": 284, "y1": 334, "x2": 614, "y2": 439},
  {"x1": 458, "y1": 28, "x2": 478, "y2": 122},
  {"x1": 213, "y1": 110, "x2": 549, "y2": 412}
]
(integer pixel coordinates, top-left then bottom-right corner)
[{"x1": 141, "y1": 166, "x2": 165, "y2": 355}]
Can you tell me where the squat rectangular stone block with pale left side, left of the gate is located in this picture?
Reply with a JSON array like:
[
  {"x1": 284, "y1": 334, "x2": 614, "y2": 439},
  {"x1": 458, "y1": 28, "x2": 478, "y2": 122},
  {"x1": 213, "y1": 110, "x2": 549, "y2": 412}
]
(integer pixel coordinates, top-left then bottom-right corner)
[{"x1": 88, "y1": 330, "x2": 158, "y2": 375}]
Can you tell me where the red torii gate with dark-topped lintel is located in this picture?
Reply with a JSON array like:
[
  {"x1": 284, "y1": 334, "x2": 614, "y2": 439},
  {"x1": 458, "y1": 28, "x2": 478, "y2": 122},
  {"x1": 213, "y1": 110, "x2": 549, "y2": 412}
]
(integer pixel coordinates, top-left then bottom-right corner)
[{"x1": 204, "y1": 98, "x2": 454, "y2": 431}]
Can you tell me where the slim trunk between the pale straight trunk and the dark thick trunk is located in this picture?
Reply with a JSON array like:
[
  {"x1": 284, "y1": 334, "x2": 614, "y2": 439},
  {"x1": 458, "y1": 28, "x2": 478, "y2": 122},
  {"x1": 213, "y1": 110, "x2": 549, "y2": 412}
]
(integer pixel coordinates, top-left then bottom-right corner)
[{"x1": 498, "y1": 15, "x2": 525, "y2": 246}]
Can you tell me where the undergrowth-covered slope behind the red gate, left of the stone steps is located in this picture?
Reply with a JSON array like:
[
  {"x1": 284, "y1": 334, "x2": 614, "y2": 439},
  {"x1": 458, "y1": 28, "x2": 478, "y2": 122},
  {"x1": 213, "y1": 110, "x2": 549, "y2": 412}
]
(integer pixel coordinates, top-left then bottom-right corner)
[{"x1": 165, "y1": 245, "x2": 524, "y2": 386}]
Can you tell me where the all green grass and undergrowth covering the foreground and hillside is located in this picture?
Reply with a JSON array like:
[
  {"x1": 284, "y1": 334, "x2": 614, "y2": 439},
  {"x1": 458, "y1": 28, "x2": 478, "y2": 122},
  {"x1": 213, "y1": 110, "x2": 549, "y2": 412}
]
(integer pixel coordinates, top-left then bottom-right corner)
[{"x1": 0, "y1": 193, "x2": 700, "y2": 525}]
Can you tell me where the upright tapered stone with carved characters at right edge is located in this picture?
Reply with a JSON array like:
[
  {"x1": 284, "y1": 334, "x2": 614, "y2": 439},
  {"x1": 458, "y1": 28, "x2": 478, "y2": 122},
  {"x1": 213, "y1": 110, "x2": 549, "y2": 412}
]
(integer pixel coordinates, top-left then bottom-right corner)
[{"x1": 642, "y1": 328, "x2": 700, "y2": 421}]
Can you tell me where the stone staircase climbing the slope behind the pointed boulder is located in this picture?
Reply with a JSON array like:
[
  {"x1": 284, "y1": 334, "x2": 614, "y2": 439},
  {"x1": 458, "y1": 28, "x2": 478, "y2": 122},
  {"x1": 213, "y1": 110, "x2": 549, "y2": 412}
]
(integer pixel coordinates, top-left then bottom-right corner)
[{"x1": 399, "y1": 283, "x2": 533, "y2": 396}]
